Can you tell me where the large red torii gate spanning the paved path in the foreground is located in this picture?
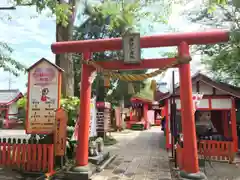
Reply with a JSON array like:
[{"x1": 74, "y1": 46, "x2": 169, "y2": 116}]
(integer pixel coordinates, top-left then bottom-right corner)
[{"x1": 51, "y1": 30, "x2": 229, "y2": 179}]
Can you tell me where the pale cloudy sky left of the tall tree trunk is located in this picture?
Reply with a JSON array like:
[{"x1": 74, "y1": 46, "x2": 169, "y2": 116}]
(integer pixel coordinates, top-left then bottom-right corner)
[{"x1": 0, "y1": 5, "x2": 55, "y2": 92}]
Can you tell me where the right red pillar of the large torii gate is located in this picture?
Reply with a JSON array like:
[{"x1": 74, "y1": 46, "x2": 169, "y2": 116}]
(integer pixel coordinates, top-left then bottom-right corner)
[{"x1": 178, "y1": 41, "x2": 206, "y2": 179}]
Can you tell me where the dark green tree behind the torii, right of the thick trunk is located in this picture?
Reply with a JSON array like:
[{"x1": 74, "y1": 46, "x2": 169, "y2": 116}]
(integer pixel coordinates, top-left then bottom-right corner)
[{"x1": 73, "y1": 1, "x2": 150, "y2": 104}]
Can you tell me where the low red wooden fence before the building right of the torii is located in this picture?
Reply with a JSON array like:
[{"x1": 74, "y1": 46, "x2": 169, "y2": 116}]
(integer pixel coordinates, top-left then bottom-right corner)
[{"x1": 198, "y1": 140, "x2": 235, "y2": 163}]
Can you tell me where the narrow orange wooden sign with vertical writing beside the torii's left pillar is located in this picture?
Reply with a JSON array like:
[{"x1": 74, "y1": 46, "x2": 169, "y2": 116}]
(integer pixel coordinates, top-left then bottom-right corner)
[{"x1": 54, "y1": 108, "x2": 68, "y2": 156}]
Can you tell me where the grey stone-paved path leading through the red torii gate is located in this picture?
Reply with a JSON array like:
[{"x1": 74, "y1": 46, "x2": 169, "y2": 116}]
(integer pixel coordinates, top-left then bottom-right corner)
[{"x1": 92, "y1": 127, "x2": 171, "y2": 180}]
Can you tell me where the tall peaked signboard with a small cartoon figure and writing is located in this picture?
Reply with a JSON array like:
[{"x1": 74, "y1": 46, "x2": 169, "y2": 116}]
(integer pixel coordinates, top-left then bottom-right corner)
[{"x1": 26, "y1": 58, "x2": 63, "y2": 134}]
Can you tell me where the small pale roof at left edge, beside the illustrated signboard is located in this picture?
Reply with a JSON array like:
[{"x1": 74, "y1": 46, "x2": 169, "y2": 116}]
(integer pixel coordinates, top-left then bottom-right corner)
[{"x1": 0, "y1": 89, "x2": 23, "y2": 105}]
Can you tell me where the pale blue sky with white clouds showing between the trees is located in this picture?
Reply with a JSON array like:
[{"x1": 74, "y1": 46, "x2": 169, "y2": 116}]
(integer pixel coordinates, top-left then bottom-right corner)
[{"x1": 0, "y1": 0, "x2": 204, "y2": 92}]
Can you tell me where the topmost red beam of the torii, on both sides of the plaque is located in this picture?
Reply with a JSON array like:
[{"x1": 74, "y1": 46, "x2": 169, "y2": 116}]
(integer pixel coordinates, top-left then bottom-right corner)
[{"x1": 51, "y1": 30, "x2": 229, "y2": 54}]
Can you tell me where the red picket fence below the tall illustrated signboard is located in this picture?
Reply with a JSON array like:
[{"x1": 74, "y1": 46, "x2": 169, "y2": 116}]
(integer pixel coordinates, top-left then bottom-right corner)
[{"x1": 0, "y1": 139, "x2": 54, "y2": 173}]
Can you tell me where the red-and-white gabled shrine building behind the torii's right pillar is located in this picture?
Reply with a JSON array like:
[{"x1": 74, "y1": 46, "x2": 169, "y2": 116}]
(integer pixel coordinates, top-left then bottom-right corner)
[{"x1": 160, "y1": 73, "x2": 240, "y2": 162}]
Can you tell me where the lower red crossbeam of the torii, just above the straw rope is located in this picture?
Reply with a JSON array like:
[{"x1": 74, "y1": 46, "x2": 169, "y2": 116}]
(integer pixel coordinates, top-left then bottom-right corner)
[{"x1": 97, "y1": 58, "x2": 176, "y2": 70}]
